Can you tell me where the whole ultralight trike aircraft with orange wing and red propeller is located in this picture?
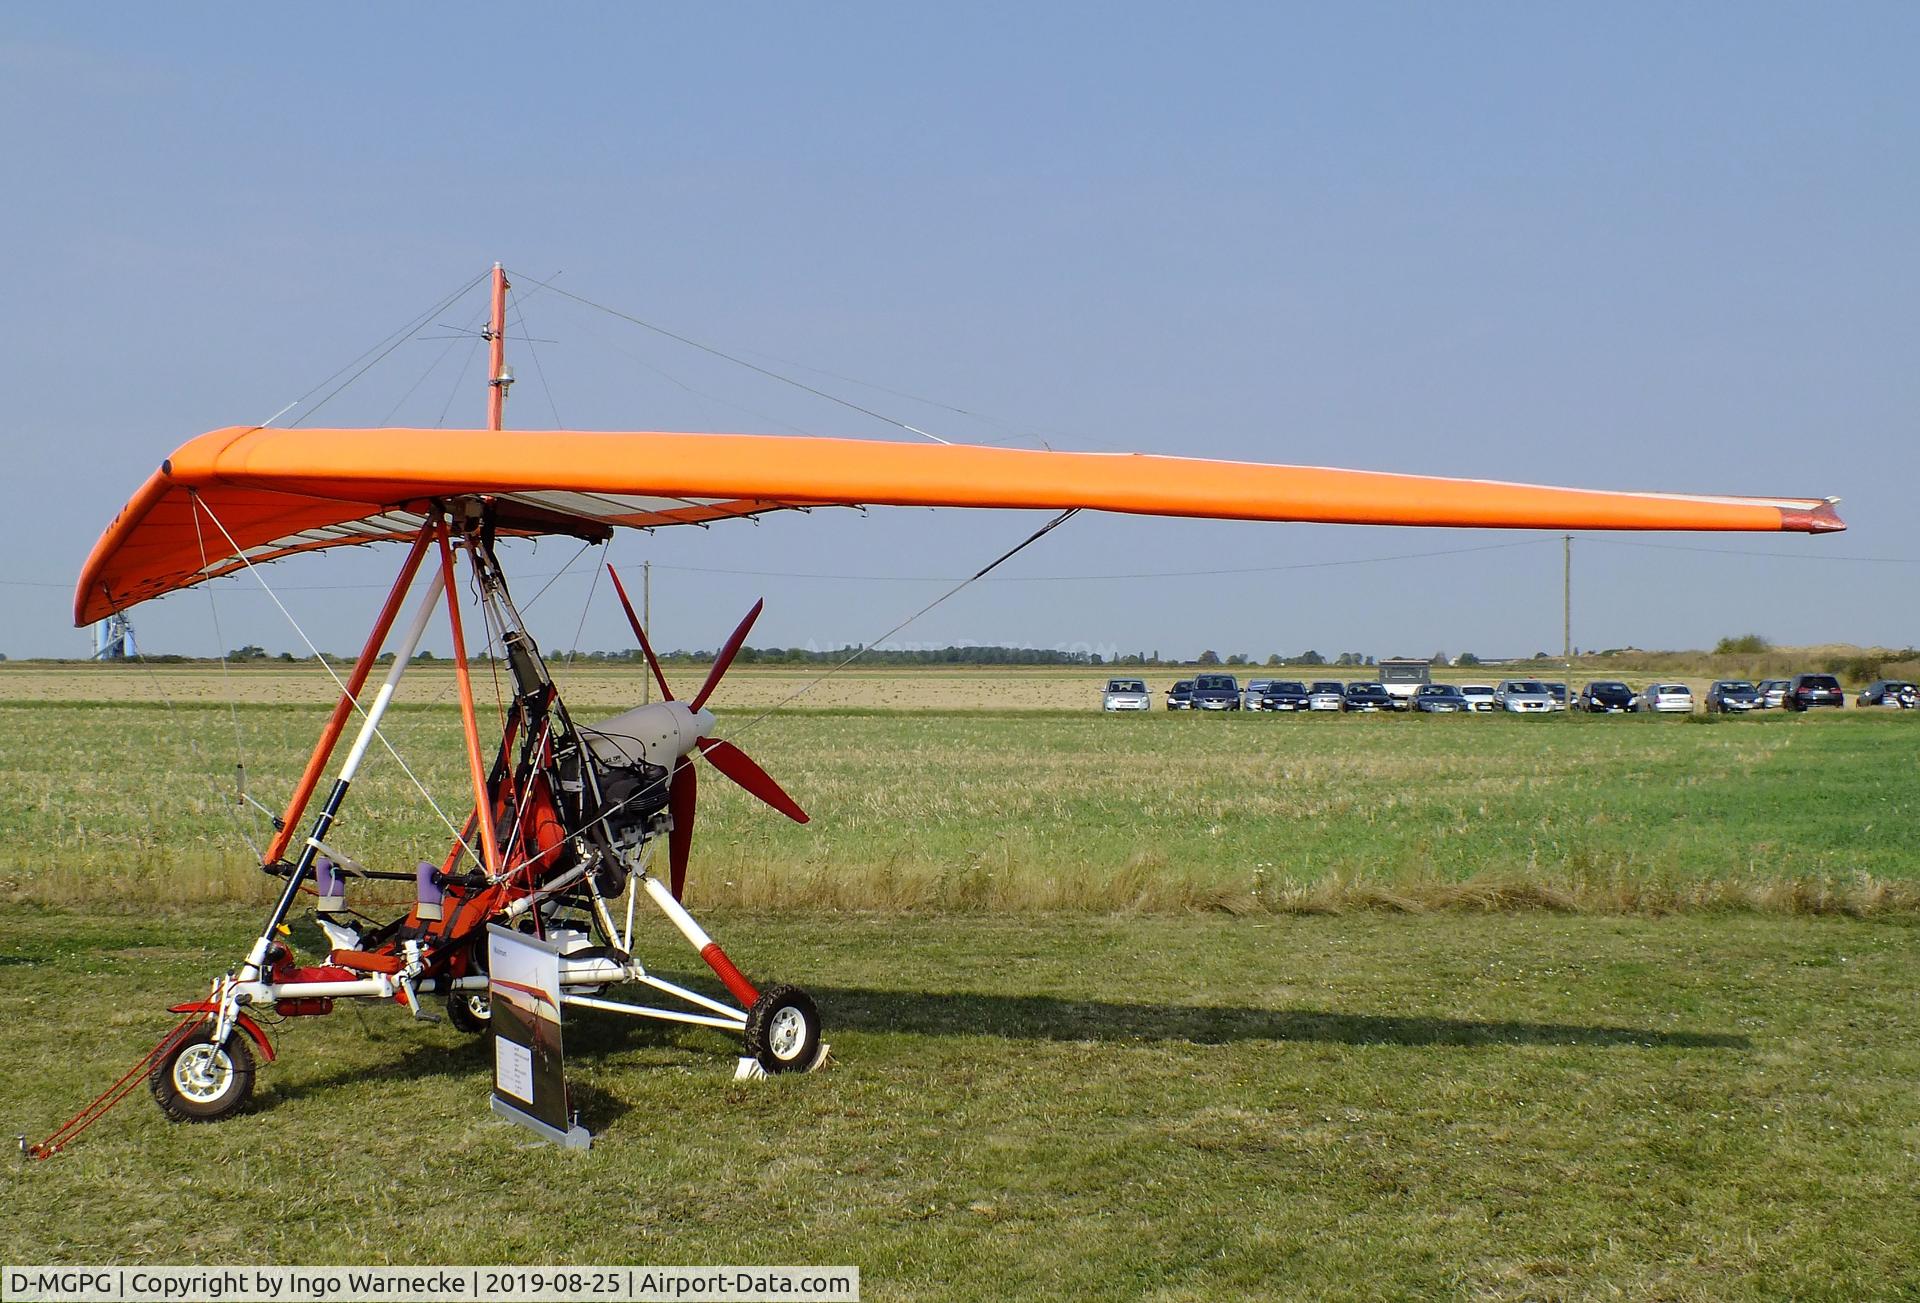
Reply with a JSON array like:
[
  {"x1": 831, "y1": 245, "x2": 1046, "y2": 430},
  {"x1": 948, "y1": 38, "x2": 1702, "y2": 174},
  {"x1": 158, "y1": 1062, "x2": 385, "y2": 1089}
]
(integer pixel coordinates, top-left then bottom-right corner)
[{"x1": 48, "y1": 267, "x2": 1843, "y2": 1153}]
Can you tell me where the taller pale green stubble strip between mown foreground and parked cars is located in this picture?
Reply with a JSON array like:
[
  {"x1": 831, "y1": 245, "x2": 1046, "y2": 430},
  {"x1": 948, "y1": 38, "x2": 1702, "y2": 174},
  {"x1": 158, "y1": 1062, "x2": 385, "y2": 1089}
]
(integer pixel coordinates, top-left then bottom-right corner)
[{"x1": 0, "y1": 679, "x2": 1920, "y2": 912}]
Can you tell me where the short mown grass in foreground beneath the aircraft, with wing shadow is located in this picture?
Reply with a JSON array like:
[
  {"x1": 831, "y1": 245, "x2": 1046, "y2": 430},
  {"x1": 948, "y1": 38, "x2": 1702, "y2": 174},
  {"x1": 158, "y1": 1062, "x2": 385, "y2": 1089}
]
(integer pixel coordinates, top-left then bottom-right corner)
[{"x1": 0, "y1": 904, "x2": 1920, "y2": 1299}]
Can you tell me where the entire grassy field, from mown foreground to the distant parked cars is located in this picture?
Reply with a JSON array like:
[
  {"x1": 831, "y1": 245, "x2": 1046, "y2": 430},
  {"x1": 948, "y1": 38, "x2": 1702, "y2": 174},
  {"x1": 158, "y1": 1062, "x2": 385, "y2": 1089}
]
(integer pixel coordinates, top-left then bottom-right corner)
[{"x1": 0, "y1": 666, "x2": 1920, "y2": 1299}]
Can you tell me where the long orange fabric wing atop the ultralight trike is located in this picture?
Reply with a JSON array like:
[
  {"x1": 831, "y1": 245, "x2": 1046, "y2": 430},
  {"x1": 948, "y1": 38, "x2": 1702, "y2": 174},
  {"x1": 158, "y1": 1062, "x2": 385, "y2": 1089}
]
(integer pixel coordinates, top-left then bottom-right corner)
[{"x1": 73, "y1": 426, "x2": 1845, "y2": 624}]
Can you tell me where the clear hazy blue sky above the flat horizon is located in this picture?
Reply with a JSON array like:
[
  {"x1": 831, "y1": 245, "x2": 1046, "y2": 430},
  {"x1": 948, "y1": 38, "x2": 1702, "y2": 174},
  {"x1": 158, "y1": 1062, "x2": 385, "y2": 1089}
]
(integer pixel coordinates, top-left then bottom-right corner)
[{"x1": 0, "y1": 4, "x2": 1920, "y2": 656}]
